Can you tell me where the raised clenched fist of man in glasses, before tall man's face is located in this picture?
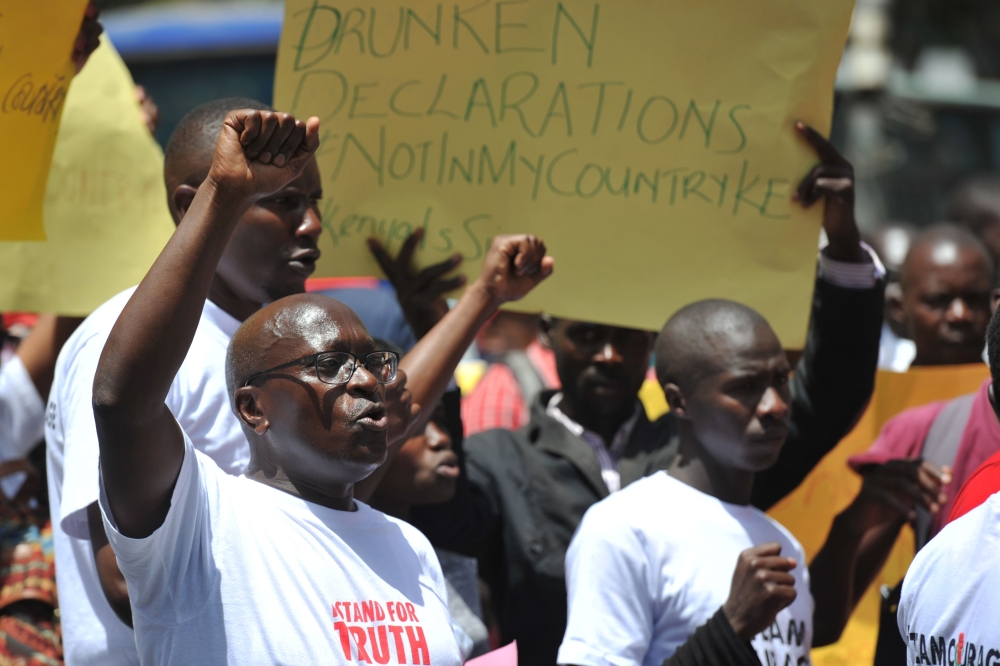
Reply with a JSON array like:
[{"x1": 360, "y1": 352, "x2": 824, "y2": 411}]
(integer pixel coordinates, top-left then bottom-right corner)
[{"x1": 208, "y1": 109, "x2": 319, "y2": 202}]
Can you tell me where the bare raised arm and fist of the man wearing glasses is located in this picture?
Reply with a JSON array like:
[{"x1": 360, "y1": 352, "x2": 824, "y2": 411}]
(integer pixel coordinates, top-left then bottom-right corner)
[{"x1": 94, "y1": 110, "x2": 319, "y2": 538}]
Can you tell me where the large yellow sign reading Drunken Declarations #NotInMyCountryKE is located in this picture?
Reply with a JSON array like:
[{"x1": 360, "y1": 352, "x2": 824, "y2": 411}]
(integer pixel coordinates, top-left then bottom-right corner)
[{"x1": 275, "y1": 0, "x2": 853, "y2": 347}]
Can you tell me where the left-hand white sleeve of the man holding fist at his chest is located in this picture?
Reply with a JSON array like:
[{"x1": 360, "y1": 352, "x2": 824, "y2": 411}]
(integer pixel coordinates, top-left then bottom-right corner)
[{"x1": 558, "y1": 509, "x2": 654, "y2": 666}]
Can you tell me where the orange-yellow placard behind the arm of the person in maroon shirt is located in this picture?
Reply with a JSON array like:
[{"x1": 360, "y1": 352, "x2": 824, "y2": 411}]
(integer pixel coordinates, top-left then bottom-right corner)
[{"x1": 768, "y1": 364, "x2": 989, "y2": 666}]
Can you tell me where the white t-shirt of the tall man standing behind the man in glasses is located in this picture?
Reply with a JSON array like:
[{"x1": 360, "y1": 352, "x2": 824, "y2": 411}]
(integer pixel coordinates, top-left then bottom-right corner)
[{"x1": 45, "y1": 289, "x2": 250, "y2": 666}]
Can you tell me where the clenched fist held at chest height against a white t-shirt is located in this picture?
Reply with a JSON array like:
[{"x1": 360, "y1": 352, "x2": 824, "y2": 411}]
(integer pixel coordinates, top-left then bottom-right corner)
[{"x1": 722, "y1": 543, "x2": 797, "y2": 641}]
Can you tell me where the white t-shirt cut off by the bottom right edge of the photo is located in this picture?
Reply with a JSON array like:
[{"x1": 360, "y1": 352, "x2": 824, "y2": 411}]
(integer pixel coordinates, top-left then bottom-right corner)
[{"x1": 897, "y1": 493, "x2": 1000, "y2": 666}]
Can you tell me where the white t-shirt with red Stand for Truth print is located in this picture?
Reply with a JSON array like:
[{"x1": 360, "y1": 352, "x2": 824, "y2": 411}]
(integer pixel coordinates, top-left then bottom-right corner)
[{"x1": 101, "y1": 430, "x2": 461, "y2": 666}]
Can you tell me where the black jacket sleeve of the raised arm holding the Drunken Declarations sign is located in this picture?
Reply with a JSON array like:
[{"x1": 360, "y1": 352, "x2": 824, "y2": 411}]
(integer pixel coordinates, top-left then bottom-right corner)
[{"x1": 751, "y1": 270, "x2": 885, "y2": 510}]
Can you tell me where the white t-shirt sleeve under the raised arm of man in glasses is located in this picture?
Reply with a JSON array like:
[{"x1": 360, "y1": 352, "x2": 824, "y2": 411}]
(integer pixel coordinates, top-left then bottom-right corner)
[{"x1": 101, "y1": 431, "x2": 224, "y2": 626}]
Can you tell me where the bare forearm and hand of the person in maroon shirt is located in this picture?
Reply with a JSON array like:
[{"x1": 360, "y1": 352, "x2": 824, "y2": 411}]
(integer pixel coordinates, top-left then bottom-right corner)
[{"x1": 809, "y1": 459, "x2": 950, "y2": 647}]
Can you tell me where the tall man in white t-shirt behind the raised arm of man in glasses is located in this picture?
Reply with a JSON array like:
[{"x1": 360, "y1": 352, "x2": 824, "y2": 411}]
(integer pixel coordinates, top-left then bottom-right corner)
[{"x1": 45, "y1": 98, "x2": 322, "y2": 666}]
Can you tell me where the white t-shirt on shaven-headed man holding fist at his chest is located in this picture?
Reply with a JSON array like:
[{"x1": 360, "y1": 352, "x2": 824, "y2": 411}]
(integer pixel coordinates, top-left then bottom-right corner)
[{"x1": 559, "y1": 472, "x2": 813, "y2": 666}]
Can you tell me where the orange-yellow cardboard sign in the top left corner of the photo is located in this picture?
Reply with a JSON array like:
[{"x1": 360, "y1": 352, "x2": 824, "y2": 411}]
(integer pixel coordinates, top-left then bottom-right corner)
[{"x1": 0, "y1": 0, "x2": 87, "y2": 240}]
